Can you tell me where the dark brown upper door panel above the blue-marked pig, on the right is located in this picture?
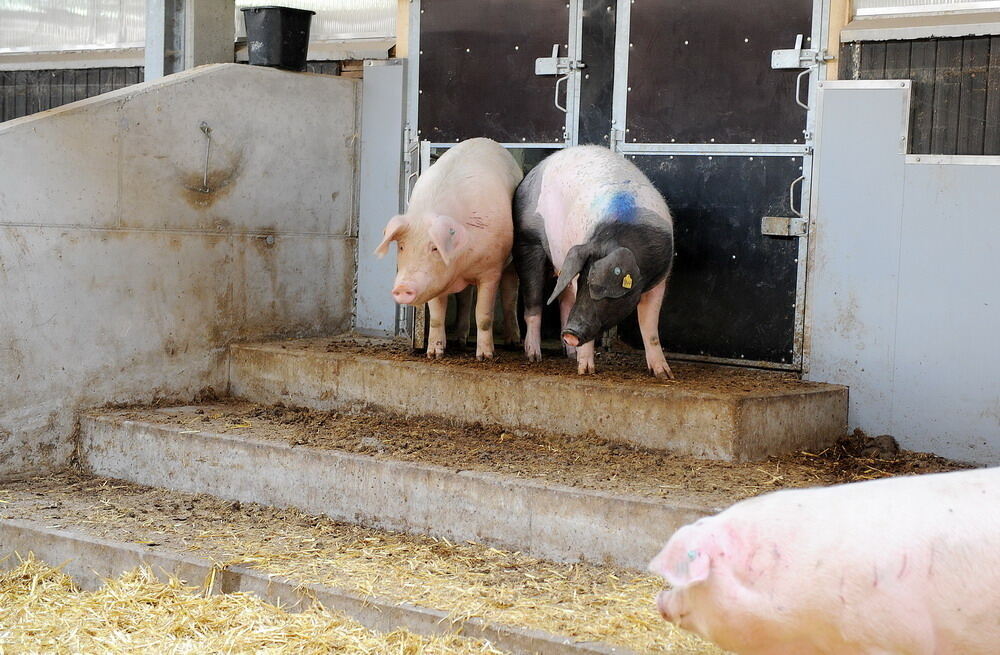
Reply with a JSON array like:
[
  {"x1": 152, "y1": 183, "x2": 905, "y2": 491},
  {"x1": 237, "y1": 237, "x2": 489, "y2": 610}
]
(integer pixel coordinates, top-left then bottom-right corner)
[{"x1": 626, "y1": 0, "x2": 813, "y2": 143}]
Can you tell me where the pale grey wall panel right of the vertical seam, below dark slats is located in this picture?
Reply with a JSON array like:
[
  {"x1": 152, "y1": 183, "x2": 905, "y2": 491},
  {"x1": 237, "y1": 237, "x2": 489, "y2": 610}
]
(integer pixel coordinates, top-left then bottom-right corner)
[{"x1": 892, "y1": 163, "x2": 1000, "y2": 464}]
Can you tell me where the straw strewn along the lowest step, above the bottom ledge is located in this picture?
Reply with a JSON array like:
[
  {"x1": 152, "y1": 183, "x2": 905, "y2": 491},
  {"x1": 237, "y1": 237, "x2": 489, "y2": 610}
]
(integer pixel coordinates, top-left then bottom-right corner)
[{"x1": 0, "y1": 473, "x2": 721, "y2": 655}]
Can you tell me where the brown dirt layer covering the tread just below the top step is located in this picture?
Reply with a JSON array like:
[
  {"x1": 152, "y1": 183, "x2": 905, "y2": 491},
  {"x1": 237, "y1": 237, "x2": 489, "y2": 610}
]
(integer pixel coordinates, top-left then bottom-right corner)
[{"x1": 109, "y1": 400, "x2": 968, "y2": 508}]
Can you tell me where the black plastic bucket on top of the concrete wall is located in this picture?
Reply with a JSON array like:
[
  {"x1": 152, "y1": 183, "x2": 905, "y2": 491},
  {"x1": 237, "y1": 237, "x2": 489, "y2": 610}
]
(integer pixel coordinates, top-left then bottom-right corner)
[{"x1": 243, "y1": 7, "x2": 316, "y2": 71}]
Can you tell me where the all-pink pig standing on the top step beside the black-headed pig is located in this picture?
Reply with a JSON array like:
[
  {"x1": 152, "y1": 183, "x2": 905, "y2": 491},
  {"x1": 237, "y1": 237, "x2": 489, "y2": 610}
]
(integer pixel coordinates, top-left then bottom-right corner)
[{"x1": 375, "y1": 138, "x2": 523, "y2": 359}]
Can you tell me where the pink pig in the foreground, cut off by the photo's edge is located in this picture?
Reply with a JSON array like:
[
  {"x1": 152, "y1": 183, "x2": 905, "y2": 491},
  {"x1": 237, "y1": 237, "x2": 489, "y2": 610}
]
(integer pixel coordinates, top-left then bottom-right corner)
[{"x1": 650, "y1": 468, "x2": 1000, "y2": 655}]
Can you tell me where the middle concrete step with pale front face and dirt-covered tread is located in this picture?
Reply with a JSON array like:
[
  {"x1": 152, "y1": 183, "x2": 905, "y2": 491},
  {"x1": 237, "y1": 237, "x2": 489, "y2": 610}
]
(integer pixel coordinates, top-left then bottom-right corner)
[{"x1": 80, "y1": 403, "x2": 720, "y2": 570}]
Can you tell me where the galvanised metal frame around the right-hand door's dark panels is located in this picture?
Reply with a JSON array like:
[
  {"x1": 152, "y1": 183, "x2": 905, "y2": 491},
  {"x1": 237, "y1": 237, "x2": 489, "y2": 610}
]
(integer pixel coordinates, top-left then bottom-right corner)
[{"x1": 611, "y1": 0, "x2": 830, "y2": 371}]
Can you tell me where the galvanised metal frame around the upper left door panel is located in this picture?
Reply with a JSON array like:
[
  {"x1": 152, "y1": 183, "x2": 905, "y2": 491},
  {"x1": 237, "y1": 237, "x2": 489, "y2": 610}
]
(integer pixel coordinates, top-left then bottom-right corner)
[{"x1": 396, "y1": 0, "x2": 583, "y2": 347}]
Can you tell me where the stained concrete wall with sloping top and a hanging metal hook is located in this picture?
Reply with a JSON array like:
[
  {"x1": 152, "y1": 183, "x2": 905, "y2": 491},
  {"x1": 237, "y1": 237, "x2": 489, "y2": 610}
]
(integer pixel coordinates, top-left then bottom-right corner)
[{"x1": 0, "y1": 64, "x2": 358, "y2": 475}]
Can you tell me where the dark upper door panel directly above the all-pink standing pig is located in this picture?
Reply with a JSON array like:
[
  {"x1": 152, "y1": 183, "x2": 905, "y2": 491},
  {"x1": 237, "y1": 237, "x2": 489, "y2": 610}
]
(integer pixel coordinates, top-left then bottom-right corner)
[{"x1": 418, "y1": 0, "x2": 569, "y2": 143}]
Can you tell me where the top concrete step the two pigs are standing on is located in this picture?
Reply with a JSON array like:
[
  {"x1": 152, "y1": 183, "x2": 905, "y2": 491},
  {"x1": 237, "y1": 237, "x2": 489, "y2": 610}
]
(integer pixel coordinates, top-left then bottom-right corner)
[{"x1": 230, "y1": 338, "x2": 847, "y2": 461}]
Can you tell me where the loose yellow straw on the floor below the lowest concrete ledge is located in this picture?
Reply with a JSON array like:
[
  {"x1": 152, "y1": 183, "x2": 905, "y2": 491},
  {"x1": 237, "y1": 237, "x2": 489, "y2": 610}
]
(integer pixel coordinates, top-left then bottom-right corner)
[{"x1": 0, "y1": 556, "x2": 501, "y2": 655}]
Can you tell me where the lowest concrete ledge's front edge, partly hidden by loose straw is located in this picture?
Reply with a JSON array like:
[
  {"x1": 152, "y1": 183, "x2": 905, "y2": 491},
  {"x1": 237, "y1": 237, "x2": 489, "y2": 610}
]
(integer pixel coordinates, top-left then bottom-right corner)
[{"x1": 0, "y1": 519, "x2": 630, "y2": 655}]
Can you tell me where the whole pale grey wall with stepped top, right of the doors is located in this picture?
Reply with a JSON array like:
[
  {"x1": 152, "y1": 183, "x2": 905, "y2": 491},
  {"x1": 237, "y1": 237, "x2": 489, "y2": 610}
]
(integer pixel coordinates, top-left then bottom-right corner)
[{"x1": 807, "y1": 81, "x2": 1000, "y2": 464}]
